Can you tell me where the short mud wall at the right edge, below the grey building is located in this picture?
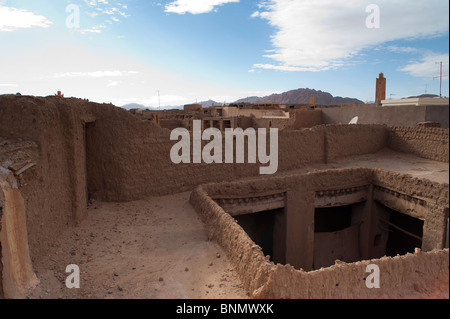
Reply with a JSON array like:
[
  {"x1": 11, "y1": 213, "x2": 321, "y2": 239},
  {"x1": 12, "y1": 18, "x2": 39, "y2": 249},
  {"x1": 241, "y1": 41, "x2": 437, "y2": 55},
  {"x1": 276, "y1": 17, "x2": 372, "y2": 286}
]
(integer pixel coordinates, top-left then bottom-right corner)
[{"x1": 388, "y1": 126, "x2": 449, "y2": 163}]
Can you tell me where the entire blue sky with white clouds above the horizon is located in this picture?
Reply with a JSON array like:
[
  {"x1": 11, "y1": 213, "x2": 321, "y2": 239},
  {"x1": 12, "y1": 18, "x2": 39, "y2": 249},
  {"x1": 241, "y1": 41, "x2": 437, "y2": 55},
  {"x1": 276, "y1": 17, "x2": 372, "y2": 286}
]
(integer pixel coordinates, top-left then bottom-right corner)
[{"x1": 0, "y1": 0, "x2": 449, "y2": 107}]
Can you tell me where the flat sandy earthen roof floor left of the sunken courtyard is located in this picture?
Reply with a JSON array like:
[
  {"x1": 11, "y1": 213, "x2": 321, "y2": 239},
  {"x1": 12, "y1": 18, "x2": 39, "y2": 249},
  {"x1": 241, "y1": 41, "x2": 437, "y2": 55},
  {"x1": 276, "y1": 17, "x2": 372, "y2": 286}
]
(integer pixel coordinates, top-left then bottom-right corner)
[{"x1": 27, "y1": 193, "x2": 249, "y2": 299}]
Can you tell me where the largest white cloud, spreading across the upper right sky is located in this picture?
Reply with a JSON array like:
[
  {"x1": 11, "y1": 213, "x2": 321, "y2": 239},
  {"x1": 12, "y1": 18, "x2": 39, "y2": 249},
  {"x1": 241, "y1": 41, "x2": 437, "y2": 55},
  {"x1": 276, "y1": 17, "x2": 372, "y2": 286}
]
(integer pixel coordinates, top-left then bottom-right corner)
[{"x1": 252, "y1": 0, "x2": 449, "y2": 71}]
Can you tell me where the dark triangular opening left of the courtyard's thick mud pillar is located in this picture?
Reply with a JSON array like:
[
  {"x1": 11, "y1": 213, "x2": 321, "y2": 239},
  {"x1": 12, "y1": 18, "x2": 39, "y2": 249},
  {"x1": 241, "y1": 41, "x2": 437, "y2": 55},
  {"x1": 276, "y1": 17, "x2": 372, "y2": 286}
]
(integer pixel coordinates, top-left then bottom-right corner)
[{"x1": 234, "y1": 208, "x2": 285, "y2": 264}]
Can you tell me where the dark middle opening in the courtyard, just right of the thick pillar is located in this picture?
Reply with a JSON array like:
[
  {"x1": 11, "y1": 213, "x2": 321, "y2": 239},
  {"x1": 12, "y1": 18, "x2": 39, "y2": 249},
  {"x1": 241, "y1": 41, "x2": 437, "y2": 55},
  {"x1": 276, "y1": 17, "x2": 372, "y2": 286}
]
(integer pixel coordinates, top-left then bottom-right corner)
[{"x1": 314, "y1": 205, "x2": 352, "y2": 233}]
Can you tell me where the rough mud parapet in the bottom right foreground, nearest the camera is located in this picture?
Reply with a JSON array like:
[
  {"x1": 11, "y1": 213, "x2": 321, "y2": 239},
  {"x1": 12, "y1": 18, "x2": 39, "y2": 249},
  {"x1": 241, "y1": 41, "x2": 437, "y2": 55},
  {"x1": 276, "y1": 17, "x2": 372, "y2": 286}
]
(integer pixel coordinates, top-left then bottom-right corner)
[{"x1": 253, "y1": 249, "x2": 449, "y2": 299}]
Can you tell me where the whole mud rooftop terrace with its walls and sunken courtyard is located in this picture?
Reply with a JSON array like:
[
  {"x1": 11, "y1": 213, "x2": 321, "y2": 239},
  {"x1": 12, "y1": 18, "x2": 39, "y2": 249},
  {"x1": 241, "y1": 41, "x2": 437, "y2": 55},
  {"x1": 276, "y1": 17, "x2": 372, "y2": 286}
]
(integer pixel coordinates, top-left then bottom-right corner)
[{"x1": 0, "y1": 95, "x2": 449, "y2": 299}]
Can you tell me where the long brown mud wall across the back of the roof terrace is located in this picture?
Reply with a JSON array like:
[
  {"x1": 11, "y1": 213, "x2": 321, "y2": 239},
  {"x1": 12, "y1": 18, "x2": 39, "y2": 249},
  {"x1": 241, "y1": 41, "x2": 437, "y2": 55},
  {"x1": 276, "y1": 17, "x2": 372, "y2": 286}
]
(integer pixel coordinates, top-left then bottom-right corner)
[{"x1": 87, "y1": 122, "x2": 387, "y2": 201}]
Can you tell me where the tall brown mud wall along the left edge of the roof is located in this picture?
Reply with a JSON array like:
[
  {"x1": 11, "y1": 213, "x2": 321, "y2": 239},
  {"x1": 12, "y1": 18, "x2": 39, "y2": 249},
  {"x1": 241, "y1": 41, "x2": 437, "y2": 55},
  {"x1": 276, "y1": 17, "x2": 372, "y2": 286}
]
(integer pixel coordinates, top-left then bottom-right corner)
[{"x1": 0, "y1": 96, "x2": 90, "y2": 260}]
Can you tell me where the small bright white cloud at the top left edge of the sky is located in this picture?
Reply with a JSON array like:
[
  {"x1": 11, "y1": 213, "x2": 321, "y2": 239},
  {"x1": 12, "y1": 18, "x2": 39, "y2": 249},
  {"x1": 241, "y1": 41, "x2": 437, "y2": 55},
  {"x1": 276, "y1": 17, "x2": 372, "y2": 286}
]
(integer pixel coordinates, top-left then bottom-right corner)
[{"x1": 0, "y1": 3, "x2": 53, "y2": 32}]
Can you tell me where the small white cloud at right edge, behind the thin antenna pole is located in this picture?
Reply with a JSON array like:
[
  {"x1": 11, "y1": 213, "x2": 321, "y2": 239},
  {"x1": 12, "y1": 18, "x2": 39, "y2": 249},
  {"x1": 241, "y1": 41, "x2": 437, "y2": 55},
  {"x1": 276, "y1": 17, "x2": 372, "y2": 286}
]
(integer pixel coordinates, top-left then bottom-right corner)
[{"x1": 399, "y1": 52, "x2": 449, "y2": 79}]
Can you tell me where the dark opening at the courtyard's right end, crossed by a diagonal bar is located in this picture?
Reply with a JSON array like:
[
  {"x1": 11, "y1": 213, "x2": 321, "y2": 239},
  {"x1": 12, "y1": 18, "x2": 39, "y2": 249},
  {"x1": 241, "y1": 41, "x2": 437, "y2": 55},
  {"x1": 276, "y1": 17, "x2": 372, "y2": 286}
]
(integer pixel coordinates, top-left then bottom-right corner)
[{"x1": 381, "y1": 209, "x2": 424, "y2": 257}]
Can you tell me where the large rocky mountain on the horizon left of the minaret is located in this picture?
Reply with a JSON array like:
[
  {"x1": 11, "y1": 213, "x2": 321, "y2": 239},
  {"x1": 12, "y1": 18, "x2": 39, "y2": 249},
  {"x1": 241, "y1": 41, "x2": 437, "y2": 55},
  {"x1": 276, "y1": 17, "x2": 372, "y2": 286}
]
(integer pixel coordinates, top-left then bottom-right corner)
[{"x1": 235, "y1": 89, "x2": 364, "y2": 105}]
